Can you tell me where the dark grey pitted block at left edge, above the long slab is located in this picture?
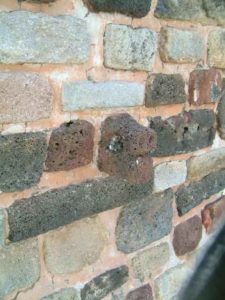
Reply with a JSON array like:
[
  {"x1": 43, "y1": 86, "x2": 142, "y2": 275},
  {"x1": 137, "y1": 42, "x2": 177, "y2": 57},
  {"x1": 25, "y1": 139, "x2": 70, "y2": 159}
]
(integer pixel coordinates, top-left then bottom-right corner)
[{"x1": 0, "y1": 132, "x2": 47, "y2": 192}]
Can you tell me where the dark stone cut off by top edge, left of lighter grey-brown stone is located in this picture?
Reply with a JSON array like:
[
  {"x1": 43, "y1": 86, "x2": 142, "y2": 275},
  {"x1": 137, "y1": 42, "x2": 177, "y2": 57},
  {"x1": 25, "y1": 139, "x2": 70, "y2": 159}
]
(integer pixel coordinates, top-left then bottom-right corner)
[{"x1": 84, "y1": 0, "x2": 151, "y2": 18}]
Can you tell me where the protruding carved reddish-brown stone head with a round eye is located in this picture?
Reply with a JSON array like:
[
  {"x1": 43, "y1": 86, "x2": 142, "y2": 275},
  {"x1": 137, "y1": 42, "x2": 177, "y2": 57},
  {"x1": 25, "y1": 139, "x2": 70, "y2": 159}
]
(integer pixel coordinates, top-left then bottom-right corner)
[{"x1": 98, "y1": 113, "x2": 155, "y2": 183}]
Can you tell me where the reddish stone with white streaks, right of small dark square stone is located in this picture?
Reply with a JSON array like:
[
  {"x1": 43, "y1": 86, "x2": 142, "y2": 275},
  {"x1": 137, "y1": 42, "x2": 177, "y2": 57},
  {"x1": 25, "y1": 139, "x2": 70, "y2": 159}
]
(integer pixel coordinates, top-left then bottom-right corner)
[{"x1": 189, "y1": 69, "x2": 222, "y2": 106}]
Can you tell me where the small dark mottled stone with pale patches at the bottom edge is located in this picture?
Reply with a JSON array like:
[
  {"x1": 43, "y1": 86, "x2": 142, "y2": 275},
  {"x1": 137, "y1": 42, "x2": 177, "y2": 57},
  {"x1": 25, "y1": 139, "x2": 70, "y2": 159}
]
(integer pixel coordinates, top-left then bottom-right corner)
[{"x1": 81, "y1": 266, "x2": 128, "y2": 300}]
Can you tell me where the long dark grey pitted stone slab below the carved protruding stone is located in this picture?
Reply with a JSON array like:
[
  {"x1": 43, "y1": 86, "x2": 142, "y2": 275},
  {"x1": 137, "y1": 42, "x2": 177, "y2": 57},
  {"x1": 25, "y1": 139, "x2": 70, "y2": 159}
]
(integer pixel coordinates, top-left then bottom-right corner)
[{"x1": 8, "y1": 177, "x2": 152, "y2": 241}]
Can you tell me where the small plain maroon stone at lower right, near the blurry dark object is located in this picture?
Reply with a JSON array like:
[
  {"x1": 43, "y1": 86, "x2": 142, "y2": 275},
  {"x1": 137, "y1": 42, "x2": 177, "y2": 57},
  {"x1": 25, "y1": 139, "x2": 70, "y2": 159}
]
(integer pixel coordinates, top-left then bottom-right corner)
[{"x1": 173, "y1": 216, "x2": 202, "y2": 256}]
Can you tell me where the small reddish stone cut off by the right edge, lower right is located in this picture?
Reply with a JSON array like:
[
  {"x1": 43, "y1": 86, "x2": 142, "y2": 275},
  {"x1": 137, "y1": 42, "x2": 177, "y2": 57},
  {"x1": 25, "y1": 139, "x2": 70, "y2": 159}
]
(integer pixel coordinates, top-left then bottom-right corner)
[{"x1": 202, "y1": 196, "x2": 225, "y2": 233}]
